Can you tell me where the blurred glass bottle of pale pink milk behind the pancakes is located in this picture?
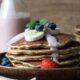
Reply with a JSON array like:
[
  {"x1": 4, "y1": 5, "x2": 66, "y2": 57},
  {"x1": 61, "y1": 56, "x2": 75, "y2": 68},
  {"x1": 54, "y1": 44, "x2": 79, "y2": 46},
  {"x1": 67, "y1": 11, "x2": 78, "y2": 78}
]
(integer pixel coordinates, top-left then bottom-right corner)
[{"x1": 0, "y1": 0, "x2": 30, "y2": 53}]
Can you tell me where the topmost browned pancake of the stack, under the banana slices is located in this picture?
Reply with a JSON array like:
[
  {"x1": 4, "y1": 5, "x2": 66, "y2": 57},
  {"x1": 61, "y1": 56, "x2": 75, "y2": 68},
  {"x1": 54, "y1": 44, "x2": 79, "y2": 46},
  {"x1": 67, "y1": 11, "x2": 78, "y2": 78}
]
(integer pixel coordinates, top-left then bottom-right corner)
[{"x1": 9, "y1": 34, "x2": 72, "y2": 50}]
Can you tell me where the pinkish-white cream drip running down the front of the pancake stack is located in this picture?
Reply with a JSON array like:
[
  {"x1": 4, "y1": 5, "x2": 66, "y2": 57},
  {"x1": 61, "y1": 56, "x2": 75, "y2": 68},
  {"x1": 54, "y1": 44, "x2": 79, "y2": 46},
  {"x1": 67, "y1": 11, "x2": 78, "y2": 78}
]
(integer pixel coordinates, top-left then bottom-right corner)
[{"x1": 46, "y1": 33, "x2": 60, "y2": 63}]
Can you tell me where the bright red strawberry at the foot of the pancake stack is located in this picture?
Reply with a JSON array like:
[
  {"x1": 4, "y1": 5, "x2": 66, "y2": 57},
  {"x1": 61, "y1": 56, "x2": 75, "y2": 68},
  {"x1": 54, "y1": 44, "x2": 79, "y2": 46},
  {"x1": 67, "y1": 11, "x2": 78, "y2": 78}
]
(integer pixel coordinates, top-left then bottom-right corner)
[{"x1": 40, "y1": 58, "x2": 59, "y2": 69}]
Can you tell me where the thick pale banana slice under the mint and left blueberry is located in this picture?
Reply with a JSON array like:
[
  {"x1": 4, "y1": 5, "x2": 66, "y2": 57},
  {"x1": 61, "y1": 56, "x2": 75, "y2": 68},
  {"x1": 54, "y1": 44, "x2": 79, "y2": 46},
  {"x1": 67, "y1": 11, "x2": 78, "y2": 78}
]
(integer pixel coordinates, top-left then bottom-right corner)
[{"x1": 24, "y1": 29, "x2": 44, "y2": 41}]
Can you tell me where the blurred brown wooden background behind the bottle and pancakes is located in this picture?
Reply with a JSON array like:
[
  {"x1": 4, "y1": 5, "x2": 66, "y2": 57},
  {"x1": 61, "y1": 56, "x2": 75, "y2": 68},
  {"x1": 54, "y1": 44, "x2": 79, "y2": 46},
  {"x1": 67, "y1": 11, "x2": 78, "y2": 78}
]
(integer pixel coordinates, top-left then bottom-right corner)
[{"x1": 0, "y1": 0, "x2": 80, "y2": 33}]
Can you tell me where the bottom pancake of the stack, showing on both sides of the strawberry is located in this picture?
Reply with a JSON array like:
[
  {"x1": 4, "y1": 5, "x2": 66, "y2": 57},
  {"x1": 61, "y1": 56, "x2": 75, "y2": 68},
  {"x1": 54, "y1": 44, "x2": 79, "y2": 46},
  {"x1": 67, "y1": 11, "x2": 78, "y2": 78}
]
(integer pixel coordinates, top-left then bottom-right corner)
[{"x1": 9, "y1": 57, "x2": 80, "y2": 69}]
